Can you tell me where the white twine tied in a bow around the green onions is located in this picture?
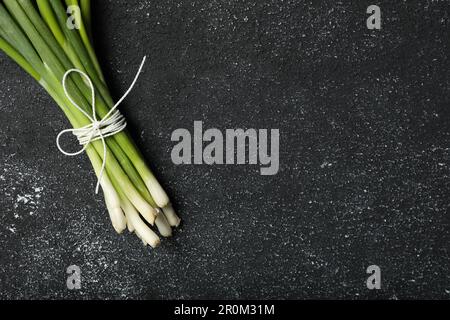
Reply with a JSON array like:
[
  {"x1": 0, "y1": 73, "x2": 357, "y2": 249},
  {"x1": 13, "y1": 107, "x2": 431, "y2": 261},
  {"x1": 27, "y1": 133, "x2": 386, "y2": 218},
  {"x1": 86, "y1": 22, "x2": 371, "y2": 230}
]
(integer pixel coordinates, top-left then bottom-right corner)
[{"x1": 56, "y1": 56, "x2": 146, "y2": 194}]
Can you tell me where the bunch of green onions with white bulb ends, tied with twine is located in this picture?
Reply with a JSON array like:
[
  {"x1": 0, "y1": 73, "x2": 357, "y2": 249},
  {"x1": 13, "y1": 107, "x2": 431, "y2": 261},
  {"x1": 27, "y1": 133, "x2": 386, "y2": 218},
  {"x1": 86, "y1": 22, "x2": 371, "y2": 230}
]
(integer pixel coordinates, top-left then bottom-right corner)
[{"x1": 0, "y1": 0, "x2": 180, "y2": 247}]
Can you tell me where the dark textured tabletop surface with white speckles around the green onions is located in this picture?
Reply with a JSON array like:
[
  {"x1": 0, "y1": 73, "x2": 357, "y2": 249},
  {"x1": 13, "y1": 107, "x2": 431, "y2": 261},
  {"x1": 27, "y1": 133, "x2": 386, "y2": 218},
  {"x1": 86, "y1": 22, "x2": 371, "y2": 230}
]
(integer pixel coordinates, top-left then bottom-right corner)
[{"x1": 0, "y1": 0, "x2": 450, "y2": 299}]
